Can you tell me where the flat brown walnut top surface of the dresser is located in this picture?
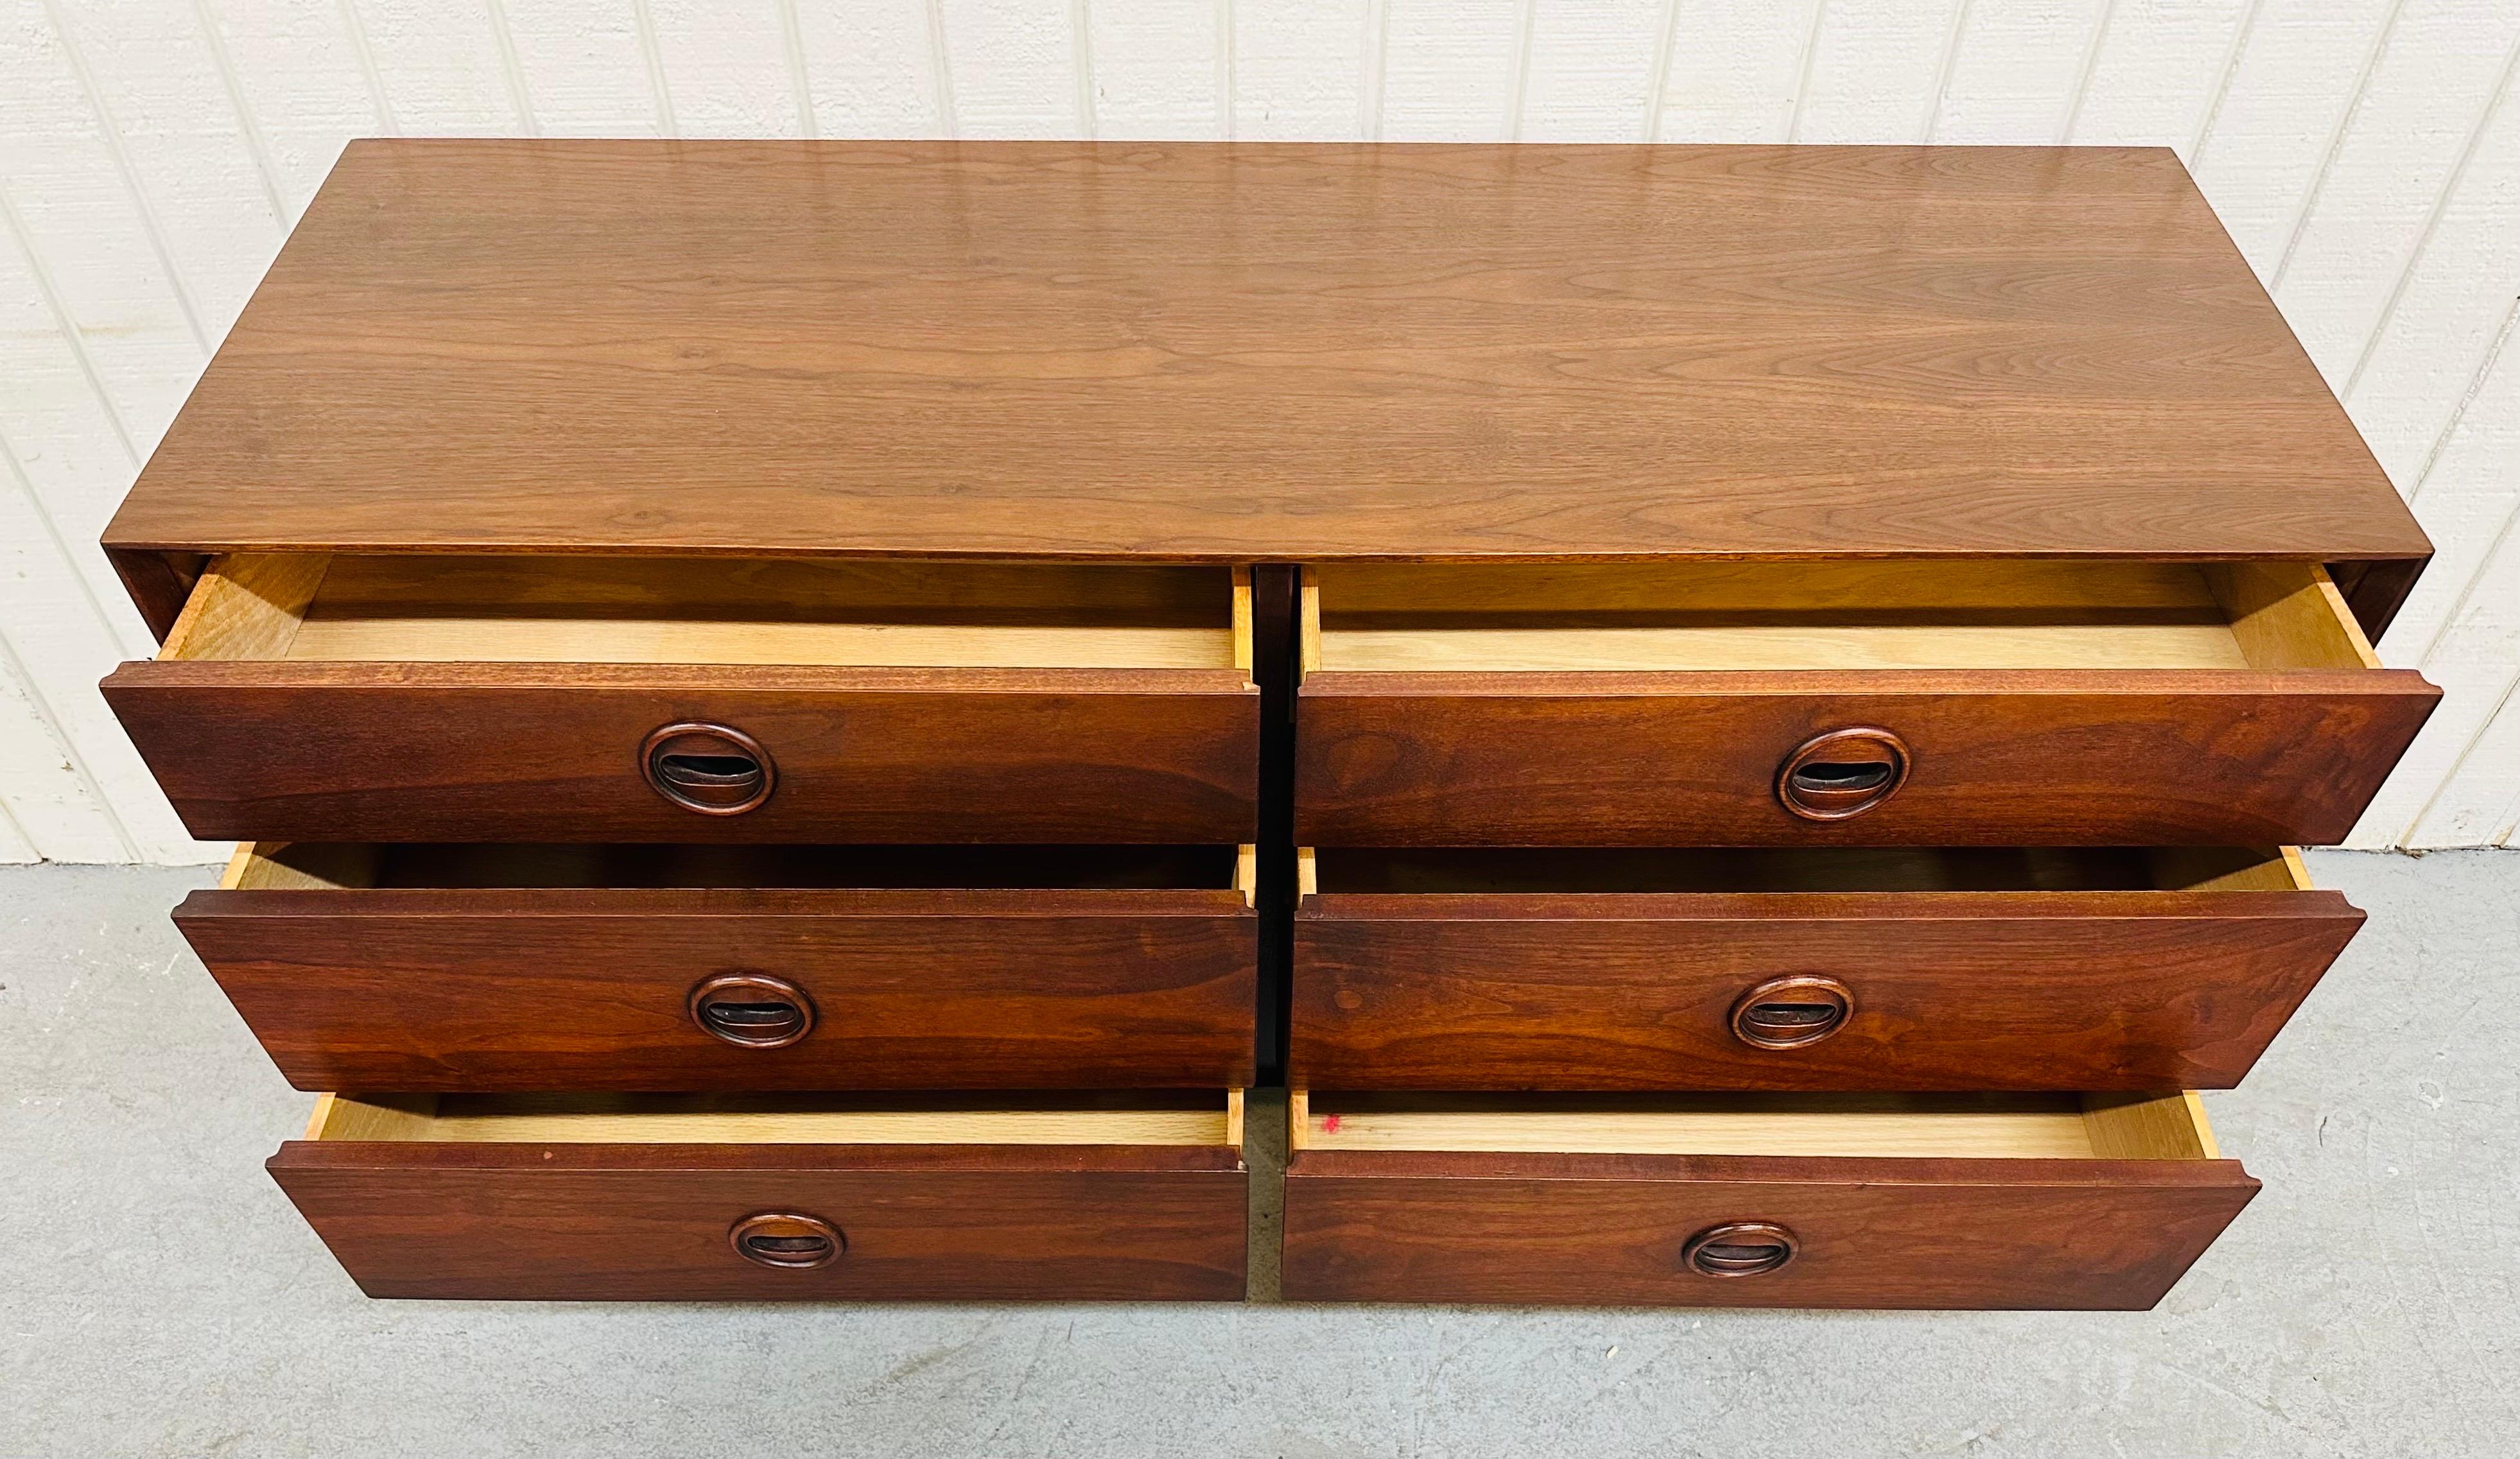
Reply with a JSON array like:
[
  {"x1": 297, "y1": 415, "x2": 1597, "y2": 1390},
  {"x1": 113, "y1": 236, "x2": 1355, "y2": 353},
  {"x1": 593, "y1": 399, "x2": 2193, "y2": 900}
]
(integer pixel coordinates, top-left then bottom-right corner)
[{"x1": 106, "y1": 141, "x2": 2429, "y2": 577}]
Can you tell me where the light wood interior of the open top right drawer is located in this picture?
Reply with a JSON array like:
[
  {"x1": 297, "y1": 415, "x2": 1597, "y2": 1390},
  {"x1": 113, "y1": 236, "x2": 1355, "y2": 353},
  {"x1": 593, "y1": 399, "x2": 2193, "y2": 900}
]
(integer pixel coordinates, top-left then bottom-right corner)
[{"x1": 1303, "y1": 560, "x2": 2379, "y2": 673}]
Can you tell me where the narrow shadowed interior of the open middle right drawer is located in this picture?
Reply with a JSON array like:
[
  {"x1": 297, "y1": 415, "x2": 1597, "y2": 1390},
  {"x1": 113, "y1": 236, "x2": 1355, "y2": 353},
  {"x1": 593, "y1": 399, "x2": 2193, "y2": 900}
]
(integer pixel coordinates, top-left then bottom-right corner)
[{"x1": 1295, "y1": 847, "x2": 2311, "y2": 895}]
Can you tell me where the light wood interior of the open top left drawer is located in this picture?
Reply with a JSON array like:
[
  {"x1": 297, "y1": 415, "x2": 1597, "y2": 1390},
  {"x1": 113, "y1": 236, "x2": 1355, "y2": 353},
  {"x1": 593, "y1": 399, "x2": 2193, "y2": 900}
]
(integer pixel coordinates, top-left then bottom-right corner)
[{"x1": 159, "y1": 555, "x2": 1250, "y2": 670}]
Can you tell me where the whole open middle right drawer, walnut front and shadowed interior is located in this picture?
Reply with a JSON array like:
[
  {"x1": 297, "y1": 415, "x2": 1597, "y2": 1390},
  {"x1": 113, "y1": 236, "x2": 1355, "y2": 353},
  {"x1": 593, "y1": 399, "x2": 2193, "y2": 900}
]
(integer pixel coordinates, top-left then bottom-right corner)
[{"x1": 1288, "y1": 847, "x2": 2364, "y2": 1091}]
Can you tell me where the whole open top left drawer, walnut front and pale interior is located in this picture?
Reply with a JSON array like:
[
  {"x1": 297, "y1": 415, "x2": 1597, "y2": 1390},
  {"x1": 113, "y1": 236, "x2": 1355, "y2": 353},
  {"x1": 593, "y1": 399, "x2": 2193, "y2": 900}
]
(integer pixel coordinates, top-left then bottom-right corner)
[{"x1": 103, "y1": 555, "x2": 1260, "y2": 844}]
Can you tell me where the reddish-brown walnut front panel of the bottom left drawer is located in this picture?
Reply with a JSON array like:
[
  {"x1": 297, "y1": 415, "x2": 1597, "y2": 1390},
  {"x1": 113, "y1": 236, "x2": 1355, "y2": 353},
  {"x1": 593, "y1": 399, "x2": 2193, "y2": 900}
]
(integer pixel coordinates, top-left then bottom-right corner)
[{"x1": 270, "y1": 1141, "x2": 1247, "y2": 1303}]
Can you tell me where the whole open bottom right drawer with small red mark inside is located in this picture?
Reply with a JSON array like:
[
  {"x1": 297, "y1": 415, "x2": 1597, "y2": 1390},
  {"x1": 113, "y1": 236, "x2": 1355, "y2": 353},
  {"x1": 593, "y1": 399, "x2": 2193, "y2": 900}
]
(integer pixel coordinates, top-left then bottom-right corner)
[{"x1": 1280, "y1": 1094, "x2": 2258, "y2": 1308}]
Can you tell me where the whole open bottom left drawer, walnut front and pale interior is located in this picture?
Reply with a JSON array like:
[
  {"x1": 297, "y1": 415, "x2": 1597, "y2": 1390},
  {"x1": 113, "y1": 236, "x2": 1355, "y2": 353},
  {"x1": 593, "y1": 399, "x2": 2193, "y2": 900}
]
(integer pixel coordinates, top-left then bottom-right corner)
[{"x1": 270, "y1": 1091, "x2": 1245, "y2": 1300}]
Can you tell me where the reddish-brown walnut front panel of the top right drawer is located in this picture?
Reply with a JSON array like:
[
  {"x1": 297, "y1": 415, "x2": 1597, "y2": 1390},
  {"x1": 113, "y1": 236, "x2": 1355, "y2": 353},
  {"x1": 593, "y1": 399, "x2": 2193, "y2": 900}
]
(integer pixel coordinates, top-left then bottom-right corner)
[{"x1": 1295, "y1": 670, "x2": 2439, "y2": 847}]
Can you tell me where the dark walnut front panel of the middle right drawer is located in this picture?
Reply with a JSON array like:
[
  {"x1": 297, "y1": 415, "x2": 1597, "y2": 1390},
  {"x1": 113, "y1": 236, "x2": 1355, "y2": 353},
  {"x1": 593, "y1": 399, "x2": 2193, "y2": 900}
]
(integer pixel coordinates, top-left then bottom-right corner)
[{"x1": 1288, "y1": 892, "x2": 2361, "y2": 1091}]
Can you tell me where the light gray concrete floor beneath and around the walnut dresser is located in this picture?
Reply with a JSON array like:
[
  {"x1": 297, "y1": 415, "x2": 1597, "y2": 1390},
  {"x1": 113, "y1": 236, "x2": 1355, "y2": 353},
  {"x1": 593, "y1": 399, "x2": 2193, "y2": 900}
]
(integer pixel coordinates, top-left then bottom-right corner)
[{"x1": 0, "y1": 852, "x2": 2520, "y2": 1459}]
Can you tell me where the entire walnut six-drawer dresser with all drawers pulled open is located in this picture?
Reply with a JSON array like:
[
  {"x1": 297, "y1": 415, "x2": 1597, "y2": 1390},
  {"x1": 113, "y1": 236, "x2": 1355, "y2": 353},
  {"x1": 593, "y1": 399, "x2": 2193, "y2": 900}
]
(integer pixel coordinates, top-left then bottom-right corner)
[{"x1": 103, "y1": 141, "x2": 2435, "y2": 1308}]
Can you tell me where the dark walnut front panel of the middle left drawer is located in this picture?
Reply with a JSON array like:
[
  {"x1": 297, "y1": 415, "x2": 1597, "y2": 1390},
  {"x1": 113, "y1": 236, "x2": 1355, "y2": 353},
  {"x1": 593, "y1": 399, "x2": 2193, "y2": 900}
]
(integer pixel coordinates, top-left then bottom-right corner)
[{"x1": 174, "y1": 887, "x2": 1255, "y2": 1091}]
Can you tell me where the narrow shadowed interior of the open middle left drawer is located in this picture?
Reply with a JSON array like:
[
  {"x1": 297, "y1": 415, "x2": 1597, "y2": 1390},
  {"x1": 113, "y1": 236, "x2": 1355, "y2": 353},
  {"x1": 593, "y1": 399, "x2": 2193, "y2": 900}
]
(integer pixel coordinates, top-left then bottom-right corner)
[{"x1": 219, "y1": 842, "x2": 1255, "y2": 904}]
